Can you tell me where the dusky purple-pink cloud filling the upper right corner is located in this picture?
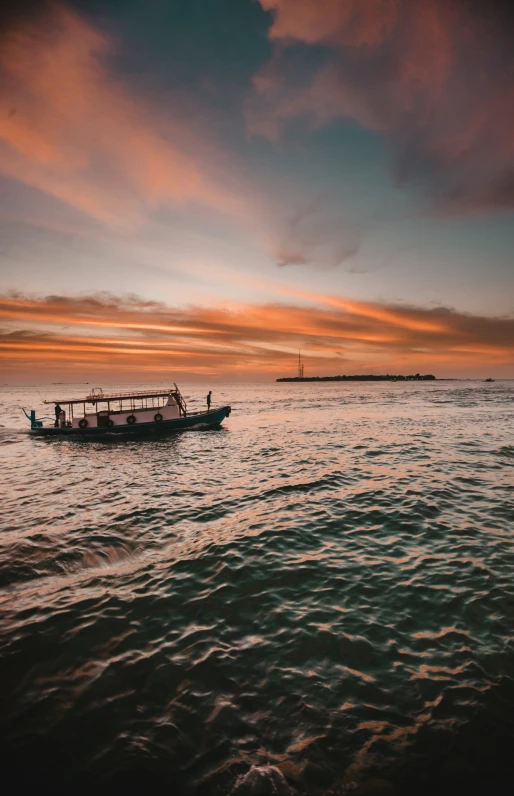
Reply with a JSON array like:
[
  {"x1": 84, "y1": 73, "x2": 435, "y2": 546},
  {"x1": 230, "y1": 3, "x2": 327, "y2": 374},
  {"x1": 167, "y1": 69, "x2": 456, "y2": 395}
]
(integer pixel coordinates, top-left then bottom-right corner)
[{"x1": 250, "y1": 0, "x2": 514, "y2": 212}]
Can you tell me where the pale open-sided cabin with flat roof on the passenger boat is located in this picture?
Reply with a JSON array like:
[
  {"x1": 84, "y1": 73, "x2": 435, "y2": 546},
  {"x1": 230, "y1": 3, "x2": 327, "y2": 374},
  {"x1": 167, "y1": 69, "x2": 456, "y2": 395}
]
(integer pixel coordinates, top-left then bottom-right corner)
[{"x1": 44, "y1": 384, "x2": 187, "y2": 428}]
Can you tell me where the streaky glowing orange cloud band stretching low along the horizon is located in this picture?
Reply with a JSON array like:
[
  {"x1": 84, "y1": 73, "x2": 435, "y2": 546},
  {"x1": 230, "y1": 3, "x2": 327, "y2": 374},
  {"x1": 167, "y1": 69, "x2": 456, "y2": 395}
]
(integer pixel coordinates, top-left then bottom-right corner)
[{"x1": 0, "y1": 294, "x2": 514, "y2": 380}]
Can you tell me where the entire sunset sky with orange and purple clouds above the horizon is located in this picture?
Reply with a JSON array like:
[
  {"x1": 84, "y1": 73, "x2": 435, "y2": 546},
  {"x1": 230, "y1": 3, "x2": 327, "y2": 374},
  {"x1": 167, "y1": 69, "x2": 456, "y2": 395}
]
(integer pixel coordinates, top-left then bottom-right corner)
[{"x1": 0, "y1": 0, "x2": 514, "y2": 383}]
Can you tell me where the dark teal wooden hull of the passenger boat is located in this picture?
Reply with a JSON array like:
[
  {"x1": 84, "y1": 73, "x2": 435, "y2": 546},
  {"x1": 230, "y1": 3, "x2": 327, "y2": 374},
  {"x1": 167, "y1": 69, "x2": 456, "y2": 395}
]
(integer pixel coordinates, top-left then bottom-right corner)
[{"x1": 29, "y1": 406, "x2": 231, "y2": 437}]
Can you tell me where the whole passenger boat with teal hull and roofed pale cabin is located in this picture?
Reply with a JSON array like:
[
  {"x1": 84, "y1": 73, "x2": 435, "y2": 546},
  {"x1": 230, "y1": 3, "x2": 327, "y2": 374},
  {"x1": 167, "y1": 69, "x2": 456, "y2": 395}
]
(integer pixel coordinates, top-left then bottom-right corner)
[{"x1": 23, "y1": 384, "x2": 231, "y2": 437}]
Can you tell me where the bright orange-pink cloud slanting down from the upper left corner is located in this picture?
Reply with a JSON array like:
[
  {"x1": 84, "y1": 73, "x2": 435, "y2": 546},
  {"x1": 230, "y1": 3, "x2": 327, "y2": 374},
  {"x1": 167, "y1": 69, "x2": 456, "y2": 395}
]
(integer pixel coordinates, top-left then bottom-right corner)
[{"x1": 0, "y1": 4, "x2": 252, "y2": 229}]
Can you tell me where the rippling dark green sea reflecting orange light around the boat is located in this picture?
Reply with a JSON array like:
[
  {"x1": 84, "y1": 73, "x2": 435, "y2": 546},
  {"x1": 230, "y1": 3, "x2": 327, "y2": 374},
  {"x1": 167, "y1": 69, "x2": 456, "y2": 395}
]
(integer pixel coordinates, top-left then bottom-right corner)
[{"x1": 0, "y1": 381, "x2": 514, "y2": 796}]
